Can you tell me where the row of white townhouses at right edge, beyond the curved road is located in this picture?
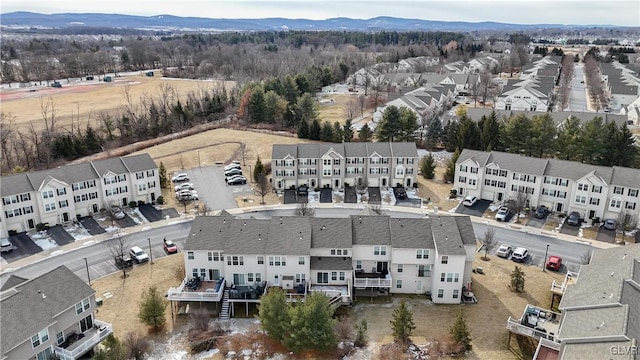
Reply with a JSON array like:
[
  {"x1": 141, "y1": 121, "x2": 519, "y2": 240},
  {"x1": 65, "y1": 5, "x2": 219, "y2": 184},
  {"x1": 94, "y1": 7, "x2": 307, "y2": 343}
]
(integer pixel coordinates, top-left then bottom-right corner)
[{"x1": 454, "y1": 149, "x2": 640, "y2": 219}]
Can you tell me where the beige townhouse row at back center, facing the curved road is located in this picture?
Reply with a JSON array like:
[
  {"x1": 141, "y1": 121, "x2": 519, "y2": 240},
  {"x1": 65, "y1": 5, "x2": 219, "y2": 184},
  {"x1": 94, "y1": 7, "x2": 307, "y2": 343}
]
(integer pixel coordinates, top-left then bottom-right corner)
[{"x1": 271, "y1": 142, "x2": 419, "y2": 190}]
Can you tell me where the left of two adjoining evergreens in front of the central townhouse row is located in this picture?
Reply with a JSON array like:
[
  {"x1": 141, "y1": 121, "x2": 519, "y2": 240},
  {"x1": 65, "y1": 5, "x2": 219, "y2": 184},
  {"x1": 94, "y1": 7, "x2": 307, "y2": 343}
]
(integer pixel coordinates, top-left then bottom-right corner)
[{"x1": 258, "y1": 287, "x2": 292, "y2": 342}]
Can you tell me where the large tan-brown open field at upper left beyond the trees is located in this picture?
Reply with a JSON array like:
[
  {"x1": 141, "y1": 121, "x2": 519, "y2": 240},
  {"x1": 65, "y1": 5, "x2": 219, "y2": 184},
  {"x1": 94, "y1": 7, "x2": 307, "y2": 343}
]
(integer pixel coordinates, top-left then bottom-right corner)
[{"x1": 0, "y1": 76, "x2": 235, "y2": 132}]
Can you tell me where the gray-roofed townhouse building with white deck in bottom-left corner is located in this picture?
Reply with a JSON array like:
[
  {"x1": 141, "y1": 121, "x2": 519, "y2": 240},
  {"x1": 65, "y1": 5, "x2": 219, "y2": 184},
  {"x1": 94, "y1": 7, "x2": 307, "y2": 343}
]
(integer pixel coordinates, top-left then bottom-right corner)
[{"x1": 0, "y1": 266, "x2": 113, "y2": 360}]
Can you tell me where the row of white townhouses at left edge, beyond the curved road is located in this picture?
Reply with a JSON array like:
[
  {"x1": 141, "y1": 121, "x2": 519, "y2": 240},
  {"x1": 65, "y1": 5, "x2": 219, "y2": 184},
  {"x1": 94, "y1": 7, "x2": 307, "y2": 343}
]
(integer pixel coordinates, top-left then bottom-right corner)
[{"x1": 0, "y1": 154, "x2": 161, "y2": 237}]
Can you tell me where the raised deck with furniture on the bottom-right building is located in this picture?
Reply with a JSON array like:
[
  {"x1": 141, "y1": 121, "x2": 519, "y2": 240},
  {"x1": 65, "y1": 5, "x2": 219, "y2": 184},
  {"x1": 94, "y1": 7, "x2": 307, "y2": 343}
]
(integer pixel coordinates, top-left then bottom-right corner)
[{"x1": 507, "y1": 305, "x2": 561, "y2": 342}]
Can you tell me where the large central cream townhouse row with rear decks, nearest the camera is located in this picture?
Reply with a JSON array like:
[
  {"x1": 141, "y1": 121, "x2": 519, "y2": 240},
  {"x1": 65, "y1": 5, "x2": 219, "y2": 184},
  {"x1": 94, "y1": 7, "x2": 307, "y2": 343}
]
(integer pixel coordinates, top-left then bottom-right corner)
[{"x1": 175, "y1": 214, "x2": 476, "y2": 310}]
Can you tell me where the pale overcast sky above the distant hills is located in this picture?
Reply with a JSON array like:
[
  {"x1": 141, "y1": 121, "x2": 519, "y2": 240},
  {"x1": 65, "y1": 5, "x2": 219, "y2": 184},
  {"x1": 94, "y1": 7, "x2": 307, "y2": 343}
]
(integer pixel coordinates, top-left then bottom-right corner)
[{"x1": 0, "y1": 0, "x2": 640, "y2": 26}]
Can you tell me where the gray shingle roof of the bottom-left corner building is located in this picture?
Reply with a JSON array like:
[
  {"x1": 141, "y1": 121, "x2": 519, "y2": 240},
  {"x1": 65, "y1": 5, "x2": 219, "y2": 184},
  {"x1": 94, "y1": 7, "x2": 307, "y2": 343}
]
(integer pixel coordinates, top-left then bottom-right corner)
[{"x1": 0, "y1": 266, "x2": 95, "y2": 354}]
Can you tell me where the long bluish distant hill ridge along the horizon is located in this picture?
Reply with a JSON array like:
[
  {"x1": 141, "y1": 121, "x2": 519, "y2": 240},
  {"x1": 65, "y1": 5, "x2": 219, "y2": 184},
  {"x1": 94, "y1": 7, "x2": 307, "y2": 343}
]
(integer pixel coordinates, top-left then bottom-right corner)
[{"x1": 0, "y1": 11, "x2": 614, "y2": 32}]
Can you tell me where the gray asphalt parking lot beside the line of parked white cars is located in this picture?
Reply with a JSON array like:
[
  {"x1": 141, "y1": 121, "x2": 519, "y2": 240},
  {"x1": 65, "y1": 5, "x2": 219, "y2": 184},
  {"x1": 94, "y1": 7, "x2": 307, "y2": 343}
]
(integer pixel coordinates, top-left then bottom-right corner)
[{"x1": 186, "y1": 166, "x2": 246, "y2": 210}]
